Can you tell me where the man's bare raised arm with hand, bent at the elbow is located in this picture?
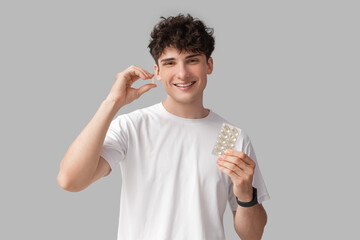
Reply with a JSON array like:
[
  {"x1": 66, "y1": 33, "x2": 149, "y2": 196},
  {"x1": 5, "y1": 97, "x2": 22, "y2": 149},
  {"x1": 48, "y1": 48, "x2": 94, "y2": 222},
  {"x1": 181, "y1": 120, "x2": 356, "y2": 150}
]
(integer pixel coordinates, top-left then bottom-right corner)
[{"x1": 57, "y1": 65, "x2": 156, "y2": 192}]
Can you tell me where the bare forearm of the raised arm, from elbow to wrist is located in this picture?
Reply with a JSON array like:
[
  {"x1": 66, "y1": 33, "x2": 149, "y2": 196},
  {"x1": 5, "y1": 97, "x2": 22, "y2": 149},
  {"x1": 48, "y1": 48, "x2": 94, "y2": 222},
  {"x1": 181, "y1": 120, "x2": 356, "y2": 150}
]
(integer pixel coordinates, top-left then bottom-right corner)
[{"x1": 58, "y1": 100, "x2": 119, "y2": 191}]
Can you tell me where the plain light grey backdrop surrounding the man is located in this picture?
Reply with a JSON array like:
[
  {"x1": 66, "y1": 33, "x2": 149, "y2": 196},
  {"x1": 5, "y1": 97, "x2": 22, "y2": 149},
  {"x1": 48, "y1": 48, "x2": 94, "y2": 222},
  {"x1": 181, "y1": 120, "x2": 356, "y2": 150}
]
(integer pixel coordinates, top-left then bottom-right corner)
[{"x1": 0, "y1": 0, "x2": 360, "y2": 240}]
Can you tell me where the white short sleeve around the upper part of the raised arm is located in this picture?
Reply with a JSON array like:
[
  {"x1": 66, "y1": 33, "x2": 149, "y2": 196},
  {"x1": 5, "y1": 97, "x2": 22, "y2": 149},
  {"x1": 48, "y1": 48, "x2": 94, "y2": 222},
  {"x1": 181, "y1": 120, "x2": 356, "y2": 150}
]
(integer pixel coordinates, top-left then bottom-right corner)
[{"x1": 100, "y1": 115, "x2": 128, "y2": 170}]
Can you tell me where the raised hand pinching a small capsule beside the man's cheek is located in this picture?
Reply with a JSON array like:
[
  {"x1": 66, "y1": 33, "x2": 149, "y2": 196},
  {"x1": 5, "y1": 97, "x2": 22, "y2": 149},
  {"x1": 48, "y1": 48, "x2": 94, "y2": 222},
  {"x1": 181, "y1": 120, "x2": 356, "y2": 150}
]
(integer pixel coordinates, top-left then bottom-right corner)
[{"x1": 106, "y1": 65, "x2": 156, "y2": 109}]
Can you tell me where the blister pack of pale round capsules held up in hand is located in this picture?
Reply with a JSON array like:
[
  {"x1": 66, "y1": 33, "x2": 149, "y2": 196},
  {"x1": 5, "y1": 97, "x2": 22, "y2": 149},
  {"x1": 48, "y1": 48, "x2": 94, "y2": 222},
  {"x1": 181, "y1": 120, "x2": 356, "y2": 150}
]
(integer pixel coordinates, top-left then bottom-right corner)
[{"x1": 212, "y1": 123, "x2": 241, "y2": 155}]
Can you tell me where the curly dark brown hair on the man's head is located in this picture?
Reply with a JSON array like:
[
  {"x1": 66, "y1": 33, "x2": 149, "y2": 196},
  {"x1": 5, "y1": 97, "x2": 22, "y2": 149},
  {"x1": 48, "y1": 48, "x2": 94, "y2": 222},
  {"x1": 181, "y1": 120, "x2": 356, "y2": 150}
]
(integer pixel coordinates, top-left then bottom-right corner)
[{"x1": 148, "y1": 14, "x2": 215, "y2": 64}]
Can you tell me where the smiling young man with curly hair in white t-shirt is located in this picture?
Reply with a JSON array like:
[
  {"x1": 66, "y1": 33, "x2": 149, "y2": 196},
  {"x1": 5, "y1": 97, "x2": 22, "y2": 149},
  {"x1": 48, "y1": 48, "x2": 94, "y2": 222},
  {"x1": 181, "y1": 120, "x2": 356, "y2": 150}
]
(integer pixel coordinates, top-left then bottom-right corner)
[{"x1": 58, "y1": 15, "x2": 269, "y2": 240}]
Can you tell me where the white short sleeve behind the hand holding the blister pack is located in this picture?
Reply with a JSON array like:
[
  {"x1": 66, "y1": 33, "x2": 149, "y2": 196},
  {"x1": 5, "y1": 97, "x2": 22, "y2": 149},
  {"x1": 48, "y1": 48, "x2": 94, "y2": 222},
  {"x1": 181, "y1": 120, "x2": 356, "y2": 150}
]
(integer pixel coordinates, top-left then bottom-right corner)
[{"x1": 228, "y1": 134, "x2": 270, "y2": 211}]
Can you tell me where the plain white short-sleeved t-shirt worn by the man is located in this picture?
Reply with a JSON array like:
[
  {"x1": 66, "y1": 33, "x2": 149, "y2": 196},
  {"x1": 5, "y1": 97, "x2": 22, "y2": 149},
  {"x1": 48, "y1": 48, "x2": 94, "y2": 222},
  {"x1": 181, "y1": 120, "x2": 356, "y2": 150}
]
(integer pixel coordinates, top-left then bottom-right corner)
[{"x1": 101, "y1": 102, "x2": 269, "y2": 240}]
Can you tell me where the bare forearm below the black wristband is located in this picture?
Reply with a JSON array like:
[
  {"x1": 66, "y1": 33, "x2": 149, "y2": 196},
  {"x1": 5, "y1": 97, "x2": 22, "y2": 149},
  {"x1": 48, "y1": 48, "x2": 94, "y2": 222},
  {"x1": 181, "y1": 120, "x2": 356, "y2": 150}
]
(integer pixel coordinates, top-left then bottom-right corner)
[{"x1": 234, "y1": 204, "x2": 267, "y2": 240}]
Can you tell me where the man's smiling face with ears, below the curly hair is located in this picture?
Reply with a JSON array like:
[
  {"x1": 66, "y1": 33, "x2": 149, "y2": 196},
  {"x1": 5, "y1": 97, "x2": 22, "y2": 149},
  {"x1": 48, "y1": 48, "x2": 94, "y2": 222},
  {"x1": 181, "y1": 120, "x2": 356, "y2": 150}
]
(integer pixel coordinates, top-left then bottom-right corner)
[{"x1": 154, "y1": 47, "x2": 213, "y2": 104}]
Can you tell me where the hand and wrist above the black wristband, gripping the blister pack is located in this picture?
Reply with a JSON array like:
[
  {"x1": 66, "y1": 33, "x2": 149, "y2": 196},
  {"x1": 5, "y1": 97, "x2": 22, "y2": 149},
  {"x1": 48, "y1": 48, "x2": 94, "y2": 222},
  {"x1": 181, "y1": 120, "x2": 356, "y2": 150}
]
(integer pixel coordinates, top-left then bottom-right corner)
[{"x1": 217, "y1": 149, "x2": 256, "y2": 202}]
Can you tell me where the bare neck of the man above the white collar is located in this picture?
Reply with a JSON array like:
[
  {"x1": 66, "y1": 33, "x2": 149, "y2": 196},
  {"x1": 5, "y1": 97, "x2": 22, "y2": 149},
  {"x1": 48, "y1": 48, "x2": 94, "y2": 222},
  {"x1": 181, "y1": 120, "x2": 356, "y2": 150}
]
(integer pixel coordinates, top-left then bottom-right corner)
[{"x1": 162, "y1": 96, "x2": 210, "y2": 119}]
